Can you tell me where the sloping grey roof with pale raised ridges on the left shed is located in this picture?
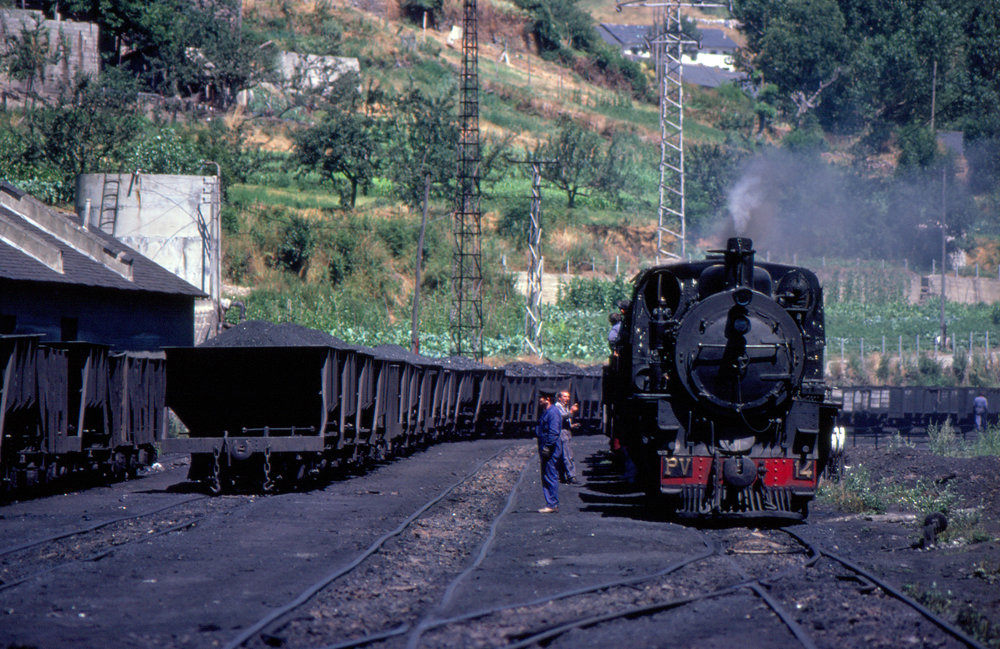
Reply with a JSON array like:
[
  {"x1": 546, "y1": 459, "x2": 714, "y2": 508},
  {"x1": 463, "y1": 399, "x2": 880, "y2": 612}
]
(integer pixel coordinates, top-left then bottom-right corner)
[{"x1": 0, "y1": 182, "x2": 207, "y2": 297}]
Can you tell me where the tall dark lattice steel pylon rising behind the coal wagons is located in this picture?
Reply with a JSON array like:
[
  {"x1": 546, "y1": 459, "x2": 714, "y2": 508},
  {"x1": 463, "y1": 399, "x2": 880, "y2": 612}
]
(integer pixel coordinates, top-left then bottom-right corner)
[{"x1": 451, "y1": 0, "x2": 483, "y2": 360}]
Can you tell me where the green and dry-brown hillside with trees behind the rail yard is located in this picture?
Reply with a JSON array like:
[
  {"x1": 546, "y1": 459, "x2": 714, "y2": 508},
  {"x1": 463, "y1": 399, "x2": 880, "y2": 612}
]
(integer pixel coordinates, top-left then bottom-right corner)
[{"x1": 0, "y1": 0, "x2": 1000, "y2": 370}]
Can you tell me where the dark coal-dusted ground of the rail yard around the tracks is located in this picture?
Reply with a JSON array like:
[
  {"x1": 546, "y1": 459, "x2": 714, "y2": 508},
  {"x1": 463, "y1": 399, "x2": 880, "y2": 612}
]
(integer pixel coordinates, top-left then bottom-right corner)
[{"x1": 0, "y1": 436, "x2": 1000, "y2": 649}]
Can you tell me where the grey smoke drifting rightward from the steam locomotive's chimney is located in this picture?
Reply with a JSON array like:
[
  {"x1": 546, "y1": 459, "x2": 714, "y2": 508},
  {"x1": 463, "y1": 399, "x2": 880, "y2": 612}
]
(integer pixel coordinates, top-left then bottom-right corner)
[{"x1": 715, "y1": 149, "x2": 972, "y2": 266}]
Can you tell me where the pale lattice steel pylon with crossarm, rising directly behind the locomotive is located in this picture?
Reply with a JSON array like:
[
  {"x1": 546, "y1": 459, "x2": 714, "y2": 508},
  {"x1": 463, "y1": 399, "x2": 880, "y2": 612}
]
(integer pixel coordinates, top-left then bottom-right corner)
[{"x1": 616, "y1": 0, "x2": 729, "y2": 259}]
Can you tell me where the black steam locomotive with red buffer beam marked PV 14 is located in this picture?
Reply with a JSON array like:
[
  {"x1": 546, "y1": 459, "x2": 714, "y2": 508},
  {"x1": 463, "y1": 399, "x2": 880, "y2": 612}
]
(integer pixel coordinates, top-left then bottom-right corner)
[{"x1": 603, "y1": 238, "x2": 837, "y2": 519}]
